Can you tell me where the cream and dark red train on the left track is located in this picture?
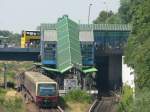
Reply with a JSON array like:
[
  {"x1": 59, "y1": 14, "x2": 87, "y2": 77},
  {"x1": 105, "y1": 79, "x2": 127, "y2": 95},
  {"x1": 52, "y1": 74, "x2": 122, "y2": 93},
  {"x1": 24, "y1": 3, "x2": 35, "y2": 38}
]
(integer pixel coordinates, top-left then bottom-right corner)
[{"x1": 19, "y1": 72, "x2": 59, "y2": 107}]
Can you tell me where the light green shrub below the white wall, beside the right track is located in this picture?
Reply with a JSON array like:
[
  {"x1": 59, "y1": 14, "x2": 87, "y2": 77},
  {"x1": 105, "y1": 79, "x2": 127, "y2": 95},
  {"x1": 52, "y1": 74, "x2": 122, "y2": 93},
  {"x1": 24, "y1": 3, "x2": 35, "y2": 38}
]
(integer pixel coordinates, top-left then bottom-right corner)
[{"x1": 118, "y1": 85, "x2": 133, "y2": 112}]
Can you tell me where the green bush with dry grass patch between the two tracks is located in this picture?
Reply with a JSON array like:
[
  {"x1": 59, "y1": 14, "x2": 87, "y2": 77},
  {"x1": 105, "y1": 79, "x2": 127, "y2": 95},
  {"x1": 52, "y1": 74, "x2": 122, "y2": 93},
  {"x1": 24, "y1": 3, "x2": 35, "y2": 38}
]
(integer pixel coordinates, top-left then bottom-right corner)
[{"x1": 60, "y1": 89, "x2": 92, "y2": 112}]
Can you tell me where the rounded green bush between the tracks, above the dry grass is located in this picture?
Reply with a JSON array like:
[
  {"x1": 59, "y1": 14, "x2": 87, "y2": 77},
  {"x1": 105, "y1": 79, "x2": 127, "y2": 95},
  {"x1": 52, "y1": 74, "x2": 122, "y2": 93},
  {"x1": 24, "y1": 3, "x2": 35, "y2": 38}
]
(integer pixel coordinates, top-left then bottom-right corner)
[{"x1": 64, "y1": 89, "x2": 92, "y2": 103}]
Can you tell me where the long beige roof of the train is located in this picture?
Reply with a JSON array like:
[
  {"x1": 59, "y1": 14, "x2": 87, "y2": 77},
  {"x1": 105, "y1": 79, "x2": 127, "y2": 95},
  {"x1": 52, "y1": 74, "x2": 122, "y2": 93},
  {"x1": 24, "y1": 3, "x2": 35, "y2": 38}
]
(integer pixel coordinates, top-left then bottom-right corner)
[{"x1": 25, "y1": 71, "x2": 56, "y2": 83}]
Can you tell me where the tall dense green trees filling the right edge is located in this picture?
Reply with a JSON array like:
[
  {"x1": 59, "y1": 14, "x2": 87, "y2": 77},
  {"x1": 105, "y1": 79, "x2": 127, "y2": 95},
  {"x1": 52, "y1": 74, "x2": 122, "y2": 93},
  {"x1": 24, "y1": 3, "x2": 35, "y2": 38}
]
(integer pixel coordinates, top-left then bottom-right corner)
[{"x1": 125, "y1": 0, "x2": 150, "y2": 112}]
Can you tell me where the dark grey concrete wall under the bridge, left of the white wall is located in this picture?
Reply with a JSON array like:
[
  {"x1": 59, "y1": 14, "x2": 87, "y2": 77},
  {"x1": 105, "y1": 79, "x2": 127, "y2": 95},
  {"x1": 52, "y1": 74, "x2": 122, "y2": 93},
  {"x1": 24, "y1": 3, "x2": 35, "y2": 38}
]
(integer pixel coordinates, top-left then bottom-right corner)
[{"x1": 108, "y1": 55, "x2": 122, "y2": 89}]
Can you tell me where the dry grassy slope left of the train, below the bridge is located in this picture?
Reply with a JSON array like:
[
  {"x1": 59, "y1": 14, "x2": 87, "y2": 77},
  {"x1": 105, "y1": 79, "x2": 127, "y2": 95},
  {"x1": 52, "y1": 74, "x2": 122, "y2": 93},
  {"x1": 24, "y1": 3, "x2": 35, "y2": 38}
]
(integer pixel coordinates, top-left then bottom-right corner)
[{"x1": 0, "y1": 61, "x2": 33, "y2": 112}]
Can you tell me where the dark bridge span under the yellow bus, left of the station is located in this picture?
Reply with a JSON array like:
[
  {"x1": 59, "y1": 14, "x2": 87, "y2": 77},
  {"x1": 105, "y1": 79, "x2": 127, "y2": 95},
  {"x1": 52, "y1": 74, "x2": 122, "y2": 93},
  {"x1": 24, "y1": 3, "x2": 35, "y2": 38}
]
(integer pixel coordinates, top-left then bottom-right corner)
[{"x1": 0, "y1": 48, "x2": 40, "y2": 61}]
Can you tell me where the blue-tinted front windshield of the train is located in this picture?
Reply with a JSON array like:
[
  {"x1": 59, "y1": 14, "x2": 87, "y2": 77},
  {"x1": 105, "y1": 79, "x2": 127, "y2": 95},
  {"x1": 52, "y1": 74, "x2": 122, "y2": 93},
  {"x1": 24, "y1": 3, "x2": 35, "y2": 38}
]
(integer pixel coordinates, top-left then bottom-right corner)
[{"x1": 39, "y1": 84, "x2": 56, "y2": 96}]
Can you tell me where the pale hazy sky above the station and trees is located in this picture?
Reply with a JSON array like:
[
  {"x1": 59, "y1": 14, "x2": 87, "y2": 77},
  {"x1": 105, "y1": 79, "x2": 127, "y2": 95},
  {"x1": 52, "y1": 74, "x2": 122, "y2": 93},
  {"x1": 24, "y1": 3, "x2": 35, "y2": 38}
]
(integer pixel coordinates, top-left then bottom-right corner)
[{"x1": 0, "y1": 0, "x2": 120, "y2": 33}]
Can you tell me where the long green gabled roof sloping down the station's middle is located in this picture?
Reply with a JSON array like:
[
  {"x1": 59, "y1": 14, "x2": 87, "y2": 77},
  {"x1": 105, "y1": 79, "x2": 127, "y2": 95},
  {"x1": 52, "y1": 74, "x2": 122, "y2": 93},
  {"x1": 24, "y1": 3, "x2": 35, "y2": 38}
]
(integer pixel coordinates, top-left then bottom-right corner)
[{"x1": 56, "y1": 16, "x2": 82, "y2": 72}]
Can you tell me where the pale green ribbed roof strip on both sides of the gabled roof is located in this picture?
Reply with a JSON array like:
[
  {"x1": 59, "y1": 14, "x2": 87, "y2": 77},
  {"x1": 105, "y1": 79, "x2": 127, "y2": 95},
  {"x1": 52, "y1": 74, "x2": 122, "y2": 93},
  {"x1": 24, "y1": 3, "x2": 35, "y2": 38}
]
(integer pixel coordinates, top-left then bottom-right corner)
[{"x1": 41, "y1": 23, "x2": 132, "y2": 31}]
